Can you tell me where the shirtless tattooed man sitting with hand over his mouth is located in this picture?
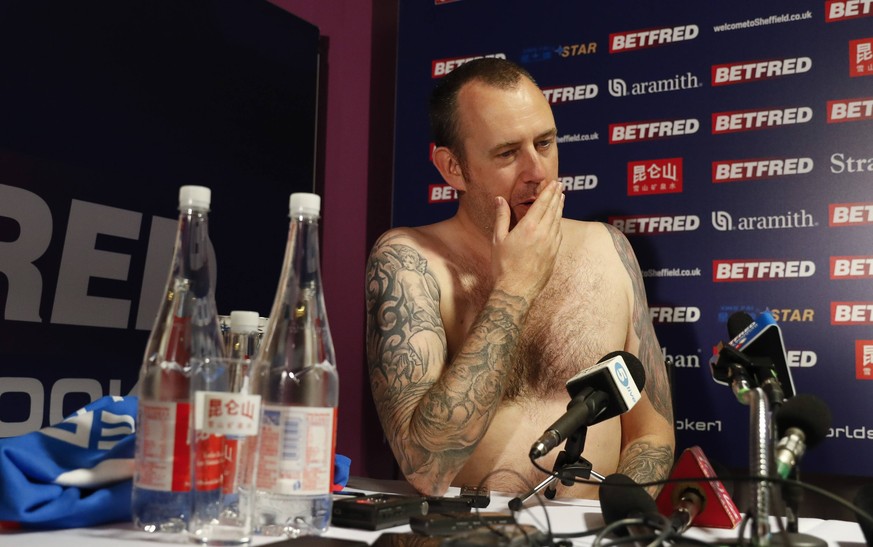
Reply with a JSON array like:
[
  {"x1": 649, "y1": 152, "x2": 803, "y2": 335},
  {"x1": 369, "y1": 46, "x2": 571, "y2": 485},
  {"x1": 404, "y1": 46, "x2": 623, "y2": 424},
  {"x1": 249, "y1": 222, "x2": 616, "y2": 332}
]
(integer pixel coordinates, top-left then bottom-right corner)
[{"x1": 367, "y1": 59, "x2": 675, "y2": 498}]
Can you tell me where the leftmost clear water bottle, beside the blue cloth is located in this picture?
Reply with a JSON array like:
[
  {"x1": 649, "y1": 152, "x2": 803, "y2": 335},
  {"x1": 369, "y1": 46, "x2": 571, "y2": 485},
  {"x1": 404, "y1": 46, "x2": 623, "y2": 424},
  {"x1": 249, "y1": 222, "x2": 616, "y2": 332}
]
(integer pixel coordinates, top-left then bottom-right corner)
[{"x1": 131, "y1": 186, "x2": 223, "y2": 532}]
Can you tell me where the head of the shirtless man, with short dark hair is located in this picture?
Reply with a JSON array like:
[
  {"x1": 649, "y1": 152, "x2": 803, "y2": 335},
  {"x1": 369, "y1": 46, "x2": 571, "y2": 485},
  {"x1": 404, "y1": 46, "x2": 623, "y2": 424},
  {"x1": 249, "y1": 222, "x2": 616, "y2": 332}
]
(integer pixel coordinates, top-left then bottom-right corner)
[{"x1": 431, "y1": 58, "x2": 558, "y2": 235}]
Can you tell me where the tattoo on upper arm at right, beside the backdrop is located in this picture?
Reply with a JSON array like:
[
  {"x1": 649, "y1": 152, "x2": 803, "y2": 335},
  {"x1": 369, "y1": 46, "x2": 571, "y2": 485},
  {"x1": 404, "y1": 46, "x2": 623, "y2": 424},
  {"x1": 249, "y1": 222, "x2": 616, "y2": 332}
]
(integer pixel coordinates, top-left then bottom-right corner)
[{"x1": 606, "y1": 224, "x2": 673, "y2": 425}]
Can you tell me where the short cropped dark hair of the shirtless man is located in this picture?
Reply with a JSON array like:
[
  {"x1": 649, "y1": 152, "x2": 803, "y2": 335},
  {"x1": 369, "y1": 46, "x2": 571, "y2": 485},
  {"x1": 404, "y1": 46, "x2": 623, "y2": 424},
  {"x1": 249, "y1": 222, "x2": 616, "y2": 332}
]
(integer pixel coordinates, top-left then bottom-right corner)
[{"x1": 429, "y1": 57, "x2": 536, "y2": 160}]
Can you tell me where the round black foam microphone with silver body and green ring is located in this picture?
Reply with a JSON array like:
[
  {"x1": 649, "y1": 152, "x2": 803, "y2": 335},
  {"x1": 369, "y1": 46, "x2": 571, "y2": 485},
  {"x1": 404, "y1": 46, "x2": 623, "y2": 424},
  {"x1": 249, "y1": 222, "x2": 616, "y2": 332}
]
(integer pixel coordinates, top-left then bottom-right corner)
[{"x1": 773, "y1": 394, "x2": 831, "y2": 479}]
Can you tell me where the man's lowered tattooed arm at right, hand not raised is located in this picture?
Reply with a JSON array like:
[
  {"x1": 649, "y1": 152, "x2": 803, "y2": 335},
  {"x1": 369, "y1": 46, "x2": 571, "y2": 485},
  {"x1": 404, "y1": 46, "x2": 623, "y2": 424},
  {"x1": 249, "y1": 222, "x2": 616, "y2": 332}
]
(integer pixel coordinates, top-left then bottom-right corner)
[{"x1": 605, "y1": 225, "x2": 676, "y2": 496}]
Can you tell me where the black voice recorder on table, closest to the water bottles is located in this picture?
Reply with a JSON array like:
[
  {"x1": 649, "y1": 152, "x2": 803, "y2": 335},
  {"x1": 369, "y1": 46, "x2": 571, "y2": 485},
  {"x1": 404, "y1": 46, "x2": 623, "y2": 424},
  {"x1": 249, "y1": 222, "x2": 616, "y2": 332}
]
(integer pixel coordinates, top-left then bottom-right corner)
[{"x1": 331, "y1": 494, "x2": 428, "y2": 530}]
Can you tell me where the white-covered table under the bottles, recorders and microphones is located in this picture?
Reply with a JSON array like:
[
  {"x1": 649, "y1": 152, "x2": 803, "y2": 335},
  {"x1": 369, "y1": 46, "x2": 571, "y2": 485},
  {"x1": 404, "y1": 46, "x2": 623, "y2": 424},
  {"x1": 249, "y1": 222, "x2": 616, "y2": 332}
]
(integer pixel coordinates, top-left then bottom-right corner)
[{"x1": 0, "y1": 477, "x2": 866, "y2": 547}]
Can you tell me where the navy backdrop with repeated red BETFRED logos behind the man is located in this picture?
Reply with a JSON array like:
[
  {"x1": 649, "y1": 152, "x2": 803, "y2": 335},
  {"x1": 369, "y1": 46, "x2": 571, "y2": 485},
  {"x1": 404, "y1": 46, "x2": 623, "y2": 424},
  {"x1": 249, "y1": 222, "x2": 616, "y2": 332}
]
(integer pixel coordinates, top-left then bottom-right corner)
[{"x1": 393, "y1": 0, "x2": 873, "y2": 476}]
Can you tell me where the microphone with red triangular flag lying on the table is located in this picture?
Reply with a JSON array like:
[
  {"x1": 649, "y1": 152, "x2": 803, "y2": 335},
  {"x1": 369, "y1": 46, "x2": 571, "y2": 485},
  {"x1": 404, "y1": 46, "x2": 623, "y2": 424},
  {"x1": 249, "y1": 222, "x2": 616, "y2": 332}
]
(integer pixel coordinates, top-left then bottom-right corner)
[{"x1": 656, "y1": 446, "x2": 742, "y2": 534}]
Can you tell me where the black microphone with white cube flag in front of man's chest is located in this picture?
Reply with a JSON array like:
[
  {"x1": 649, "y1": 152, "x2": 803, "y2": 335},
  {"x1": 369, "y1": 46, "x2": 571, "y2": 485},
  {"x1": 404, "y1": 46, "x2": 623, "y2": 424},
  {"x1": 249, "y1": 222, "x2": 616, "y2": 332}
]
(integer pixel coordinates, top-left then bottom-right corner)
[{"x1": 530, "y1": 351, "x2": 646, "y2": 460}]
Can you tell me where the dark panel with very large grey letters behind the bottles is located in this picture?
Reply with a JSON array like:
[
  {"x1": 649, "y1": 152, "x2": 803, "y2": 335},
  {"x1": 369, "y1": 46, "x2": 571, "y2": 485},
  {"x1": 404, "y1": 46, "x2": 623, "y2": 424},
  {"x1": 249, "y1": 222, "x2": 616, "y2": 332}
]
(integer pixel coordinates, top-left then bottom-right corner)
[{"x1": 0, "y1": 0, "x2": 318, "y2": 437}]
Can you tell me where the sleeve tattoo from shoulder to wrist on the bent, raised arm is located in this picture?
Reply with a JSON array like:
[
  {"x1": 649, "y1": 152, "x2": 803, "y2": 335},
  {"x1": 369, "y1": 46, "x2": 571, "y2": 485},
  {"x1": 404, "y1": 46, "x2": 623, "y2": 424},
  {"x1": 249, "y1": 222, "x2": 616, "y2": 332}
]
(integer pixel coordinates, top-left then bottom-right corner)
[{"x1": 366, "y1": 238, "x2": 526, "y2": 477}]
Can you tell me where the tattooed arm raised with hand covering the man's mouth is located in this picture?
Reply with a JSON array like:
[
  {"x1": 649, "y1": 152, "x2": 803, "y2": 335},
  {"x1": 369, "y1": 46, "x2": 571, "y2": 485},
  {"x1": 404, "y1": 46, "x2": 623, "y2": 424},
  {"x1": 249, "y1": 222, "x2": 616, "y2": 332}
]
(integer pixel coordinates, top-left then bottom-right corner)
[{"x1": 366, "y1": 184, "x2": 563, "y2": 495}]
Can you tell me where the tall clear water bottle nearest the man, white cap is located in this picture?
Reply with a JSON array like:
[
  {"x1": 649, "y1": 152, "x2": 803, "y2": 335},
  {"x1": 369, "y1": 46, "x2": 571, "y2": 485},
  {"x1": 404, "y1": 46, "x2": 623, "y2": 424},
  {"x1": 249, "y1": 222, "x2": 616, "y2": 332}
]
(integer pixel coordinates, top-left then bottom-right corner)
[{"x1": 252, "y1": 193, "x2": 339, "y2": 537}]
